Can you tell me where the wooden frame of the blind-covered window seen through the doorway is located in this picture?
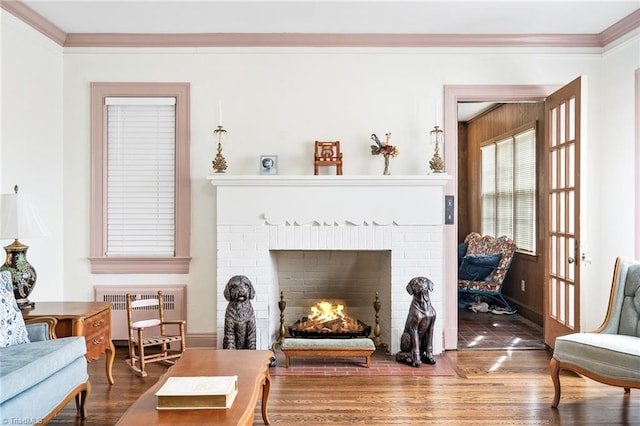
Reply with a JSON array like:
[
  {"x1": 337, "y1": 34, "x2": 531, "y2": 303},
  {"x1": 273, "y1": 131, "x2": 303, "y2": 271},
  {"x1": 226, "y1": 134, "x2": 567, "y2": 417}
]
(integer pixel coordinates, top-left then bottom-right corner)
[{"x1": 479, "y1": 121, "x2": 539, "y2": 256}]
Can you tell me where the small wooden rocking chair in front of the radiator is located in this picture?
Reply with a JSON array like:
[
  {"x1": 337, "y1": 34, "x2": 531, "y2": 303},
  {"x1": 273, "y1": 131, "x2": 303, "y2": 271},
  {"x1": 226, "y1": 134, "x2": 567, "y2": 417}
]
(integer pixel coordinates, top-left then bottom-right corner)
[{"x1": 127, "y1": 291, "x2": 186, "y2": 377}]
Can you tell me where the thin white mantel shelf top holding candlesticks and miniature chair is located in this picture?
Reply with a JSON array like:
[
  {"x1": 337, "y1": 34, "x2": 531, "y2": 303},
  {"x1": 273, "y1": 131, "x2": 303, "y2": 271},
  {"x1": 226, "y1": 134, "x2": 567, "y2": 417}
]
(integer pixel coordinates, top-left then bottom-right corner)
[{"x1": 207, "y1": 173, "x2": 451, "y2": 187}]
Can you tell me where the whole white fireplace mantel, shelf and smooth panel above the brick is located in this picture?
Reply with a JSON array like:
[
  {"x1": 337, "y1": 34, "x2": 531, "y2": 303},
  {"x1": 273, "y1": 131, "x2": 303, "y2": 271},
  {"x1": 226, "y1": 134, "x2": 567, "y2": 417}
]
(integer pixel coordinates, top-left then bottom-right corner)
[{"x1": 209, "y1": 174, "x2": 450, "y2": 225}]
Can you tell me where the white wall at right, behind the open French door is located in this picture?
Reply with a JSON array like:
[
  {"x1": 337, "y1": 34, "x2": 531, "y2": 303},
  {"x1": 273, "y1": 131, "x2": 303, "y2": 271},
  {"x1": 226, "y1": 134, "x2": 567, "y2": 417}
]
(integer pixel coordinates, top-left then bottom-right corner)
[{"x1": 581, "y1": 32, "x2": 640, "y2": 330}]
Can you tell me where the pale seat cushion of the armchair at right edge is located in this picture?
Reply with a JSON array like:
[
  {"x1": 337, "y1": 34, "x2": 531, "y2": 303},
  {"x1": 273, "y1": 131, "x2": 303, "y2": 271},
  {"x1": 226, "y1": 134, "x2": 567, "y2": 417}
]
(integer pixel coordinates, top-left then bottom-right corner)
[{"x1": 553, "y1": 333, "x2": 640, "y2": 380}]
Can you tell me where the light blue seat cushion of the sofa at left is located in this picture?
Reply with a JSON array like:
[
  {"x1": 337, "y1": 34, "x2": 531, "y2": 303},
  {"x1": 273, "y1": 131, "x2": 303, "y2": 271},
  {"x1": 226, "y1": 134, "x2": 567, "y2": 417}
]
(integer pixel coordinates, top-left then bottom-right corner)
[{"x1": 0, "y1": 336, "x2": 87, "y2": 403}]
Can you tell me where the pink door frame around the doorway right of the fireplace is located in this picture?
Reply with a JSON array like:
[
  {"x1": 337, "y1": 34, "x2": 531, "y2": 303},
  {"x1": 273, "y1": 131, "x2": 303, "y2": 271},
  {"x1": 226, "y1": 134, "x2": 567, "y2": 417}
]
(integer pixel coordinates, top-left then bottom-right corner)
[{"x1": 443, "y1": 84, "x2": 562, "y2": 350}]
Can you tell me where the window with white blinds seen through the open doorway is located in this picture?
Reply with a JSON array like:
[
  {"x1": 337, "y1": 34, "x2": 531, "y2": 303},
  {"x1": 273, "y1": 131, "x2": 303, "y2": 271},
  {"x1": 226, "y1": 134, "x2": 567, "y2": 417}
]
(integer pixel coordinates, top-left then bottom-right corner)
[{"x1": 480, "y1": 127, "x2": 536, "y2": 254}]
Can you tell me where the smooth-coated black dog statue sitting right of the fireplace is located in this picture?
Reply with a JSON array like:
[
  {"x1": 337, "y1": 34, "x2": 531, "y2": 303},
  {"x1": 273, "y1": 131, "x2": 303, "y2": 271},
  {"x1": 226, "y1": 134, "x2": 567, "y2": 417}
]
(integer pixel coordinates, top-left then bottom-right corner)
[{"x1": 396, "y1": 277, "x2": 436, "y2": 367}]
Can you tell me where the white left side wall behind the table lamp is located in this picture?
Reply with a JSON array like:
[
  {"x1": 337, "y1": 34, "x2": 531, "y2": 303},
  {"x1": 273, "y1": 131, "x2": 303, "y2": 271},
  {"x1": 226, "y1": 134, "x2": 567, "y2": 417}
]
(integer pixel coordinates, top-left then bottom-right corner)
[{"x1": 0, "y1": 9, "x2": 64, "y2": 301}]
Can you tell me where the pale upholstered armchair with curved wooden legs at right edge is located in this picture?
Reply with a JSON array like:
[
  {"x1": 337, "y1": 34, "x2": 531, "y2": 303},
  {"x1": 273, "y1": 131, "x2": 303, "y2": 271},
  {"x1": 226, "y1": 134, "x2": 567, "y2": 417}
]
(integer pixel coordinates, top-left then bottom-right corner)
[{"x1": 550, "y1": 258, "x2": 640, "y2": 408}]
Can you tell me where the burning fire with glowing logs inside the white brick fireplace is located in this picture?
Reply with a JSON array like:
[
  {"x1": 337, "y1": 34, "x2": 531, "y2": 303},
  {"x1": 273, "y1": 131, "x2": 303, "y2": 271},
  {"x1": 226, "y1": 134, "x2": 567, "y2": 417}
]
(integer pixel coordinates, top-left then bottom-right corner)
[{"x1": 293, "y1": 301, "x2": 364, "y2": 333}]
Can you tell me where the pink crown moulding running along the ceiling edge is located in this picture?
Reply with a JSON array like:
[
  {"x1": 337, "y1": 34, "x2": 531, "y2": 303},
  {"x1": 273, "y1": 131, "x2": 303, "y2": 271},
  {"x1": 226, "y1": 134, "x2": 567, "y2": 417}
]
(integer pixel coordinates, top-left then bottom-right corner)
[{"x1": 0, "y1": 0, "x2": 640, "y2": 47}]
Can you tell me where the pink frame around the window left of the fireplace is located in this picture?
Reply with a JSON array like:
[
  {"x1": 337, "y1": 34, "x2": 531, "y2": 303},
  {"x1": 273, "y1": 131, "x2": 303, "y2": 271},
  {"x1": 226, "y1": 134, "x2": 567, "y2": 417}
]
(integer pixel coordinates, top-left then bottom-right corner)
[{"x1": 88, "y1": 82, "x2": 191, "y2": 274}]
